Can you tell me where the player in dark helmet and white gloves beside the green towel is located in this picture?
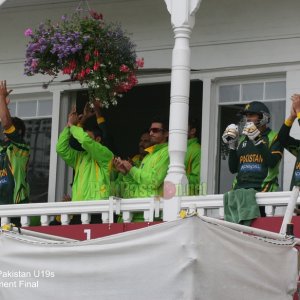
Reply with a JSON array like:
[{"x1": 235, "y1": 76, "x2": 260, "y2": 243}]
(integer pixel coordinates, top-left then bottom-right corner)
[{"x1": 222, "y1": 101, "x2": 283, "y2": 216}]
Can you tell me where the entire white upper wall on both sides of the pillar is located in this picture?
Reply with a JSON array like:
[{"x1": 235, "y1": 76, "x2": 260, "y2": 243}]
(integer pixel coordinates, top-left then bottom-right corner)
[{"x1": 0, "y1": 0, "x2": 300, "y2": 83}]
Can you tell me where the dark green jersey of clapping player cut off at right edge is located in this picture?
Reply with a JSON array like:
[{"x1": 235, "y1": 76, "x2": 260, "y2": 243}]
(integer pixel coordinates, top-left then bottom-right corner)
[{"x1": 278, "y1": 119, "x2": 300, "y2": 190}]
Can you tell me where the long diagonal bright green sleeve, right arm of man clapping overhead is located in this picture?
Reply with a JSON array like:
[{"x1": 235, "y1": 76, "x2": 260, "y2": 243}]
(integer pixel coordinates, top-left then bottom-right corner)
[{"x1": 70, "y1": 126, "x2": 113, "y2": 167}]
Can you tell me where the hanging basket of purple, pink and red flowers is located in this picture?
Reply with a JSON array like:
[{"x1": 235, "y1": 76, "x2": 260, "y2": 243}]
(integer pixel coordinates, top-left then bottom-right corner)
[{"x1": 25, "y1": 11, "x2": 144, "y2": 107}]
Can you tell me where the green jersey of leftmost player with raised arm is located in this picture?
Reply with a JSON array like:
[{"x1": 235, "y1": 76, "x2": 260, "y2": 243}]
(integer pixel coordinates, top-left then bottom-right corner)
[{"x1": 0, "y1": 126, "x2": 30, "y2": 204}]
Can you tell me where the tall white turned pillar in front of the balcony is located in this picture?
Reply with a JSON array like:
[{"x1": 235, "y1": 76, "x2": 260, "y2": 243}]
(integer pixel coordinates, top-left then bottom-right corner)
[{"x1": 164, "y1": 0, "x2": 201, "y2": 221}]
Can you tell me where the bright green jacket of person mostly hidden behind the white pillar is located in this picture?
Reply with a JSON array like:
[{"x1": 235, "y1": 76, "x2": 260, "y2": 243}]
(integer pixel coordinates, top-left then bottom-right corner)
[{"x1": 184, "y1": 138, "x2": 201, "y2": 195}]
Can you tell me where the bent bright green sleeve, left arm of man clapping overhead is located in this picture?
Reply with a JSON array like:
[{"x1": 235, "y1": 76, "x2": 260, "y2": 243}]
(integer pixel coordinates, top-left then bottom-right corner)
[{"x1": 56, "y1": 127, "x2": 78, "y2": 168}]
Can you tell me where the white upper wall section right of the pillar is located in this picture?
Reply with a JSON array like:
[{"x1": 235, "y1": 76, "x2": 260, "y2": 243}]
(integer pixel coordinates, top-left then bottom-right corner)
[{"x1": 192, "y1": 0, "x2": 300, "y2": 69}]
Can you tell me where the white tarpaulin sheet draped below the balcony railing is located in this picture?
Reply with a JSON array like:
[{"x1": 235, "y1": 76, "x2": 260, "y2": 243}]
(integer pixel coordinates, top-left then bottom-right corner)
[{"x1": 0, "y1": 217, "x2": 297, "y2": 300}]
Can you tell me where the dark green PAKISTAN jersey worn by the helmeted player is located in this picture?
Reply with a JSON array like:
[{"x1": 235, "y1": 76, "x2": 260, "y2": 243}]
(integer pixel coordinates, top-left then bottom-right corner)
[{"x1": 228, "y1": 128, "x2": 283, "y2": 192}]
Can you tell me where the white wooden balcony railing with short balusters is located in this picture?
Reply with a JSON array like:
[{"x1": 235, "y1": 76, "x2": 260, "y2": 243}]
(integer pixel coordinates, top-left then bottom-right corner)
[{"x1": 0, "y1": 192, "x2": 300, "y2": 226}]
